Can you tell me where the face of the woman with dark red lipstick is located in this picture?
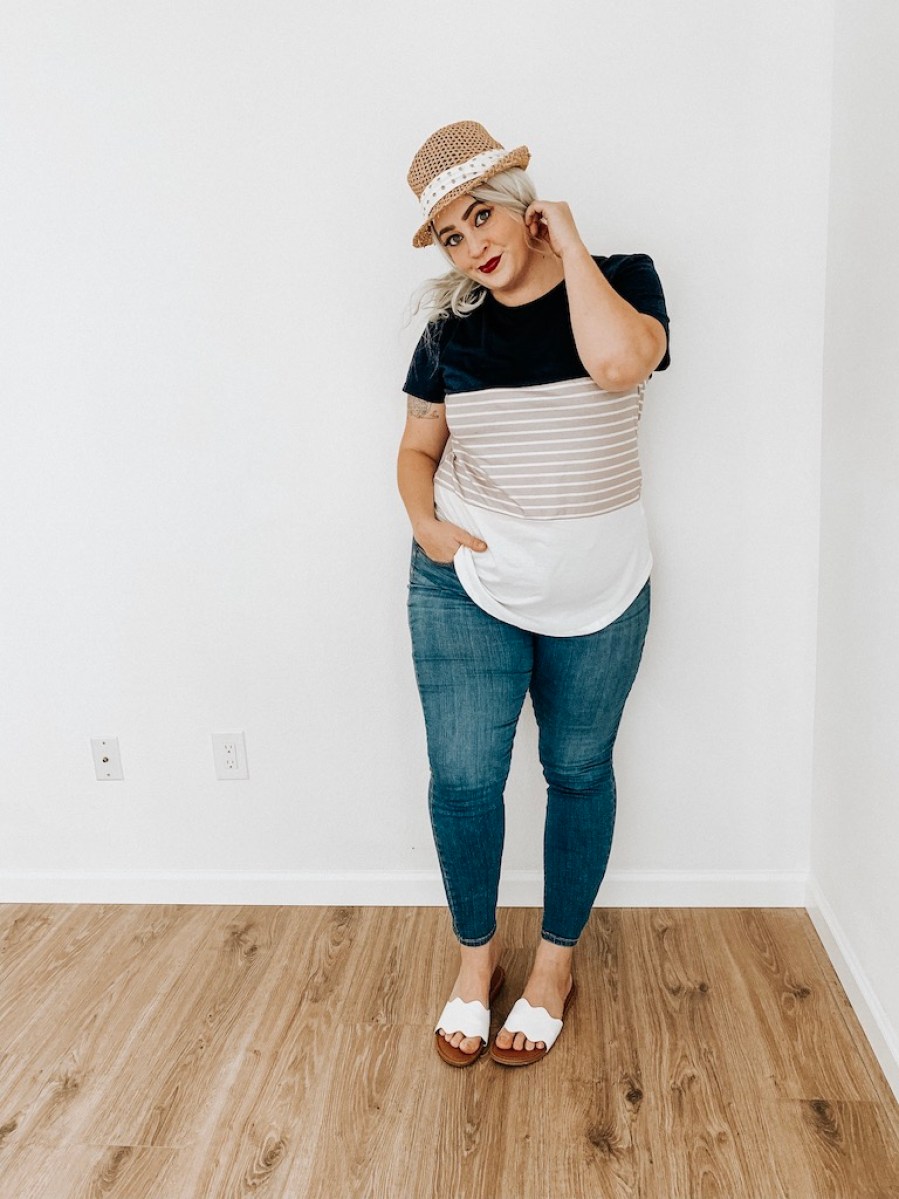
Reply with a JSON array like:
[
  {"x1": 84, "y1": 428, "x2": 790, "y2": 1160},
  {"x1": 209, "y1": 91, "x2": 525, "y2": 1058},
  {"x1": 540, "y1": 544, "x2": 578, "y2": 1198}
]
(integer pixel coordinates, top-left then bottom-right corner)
[{"x1": 435, "y1": 195, "x2": 533, "y2": 291}]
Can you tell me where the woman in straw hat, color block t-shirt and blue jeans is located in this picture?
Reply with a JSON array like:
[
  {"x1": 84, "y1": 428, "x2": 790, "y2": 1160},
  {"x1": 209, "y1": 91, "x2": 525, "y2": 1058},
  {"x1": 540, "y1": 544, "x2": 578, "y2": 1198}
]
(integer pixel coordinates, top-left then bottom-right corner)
[{"x1": 397, "y1": 121, "x2": 669, "y2": 1066}]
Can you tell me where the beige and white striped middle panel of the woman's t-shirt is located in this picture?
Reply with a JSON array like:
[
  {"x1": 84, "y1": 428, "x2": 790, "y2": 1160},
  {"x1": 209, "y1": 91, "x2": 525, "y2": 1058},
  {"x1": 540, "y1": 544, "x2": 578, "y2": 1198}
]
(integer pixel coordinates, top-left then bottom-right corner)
[{"x1": 434, "y1": 376, "x2": 645, "y2": 520}]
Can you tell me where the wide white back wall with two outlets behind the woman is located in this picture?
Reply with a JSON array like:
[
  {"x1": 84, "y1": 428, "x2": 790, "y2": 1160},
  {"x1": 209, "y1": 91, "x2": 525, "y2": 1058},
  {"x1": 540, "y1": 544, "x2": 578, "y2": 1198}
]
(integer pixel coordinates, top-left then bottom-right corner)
[{"x1": 0, "y1": 0, "x2": 834, "y2": 904}]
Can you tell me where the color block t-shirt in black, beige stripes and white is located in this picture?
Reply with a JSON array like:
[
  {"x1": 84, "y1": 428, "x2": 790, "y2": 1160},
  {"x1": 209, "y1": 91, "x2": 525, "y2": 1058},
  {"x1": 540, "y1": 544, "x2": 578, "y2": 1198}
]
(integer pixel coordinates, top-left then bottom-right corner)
[{"x1": 403, "y1": 254, "x2": 670, "y2": 637}]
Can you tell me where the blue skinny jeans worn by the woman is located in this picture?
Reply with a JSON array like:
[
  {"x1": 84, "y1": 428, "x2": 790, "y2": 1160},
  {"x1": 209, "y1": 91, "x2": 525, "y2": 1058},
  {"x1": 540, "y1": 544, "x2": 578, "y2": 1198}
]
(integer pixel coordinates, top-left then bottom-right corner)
[{"x1": 408, "y1": 540, "x2": 650, "y2": 945}]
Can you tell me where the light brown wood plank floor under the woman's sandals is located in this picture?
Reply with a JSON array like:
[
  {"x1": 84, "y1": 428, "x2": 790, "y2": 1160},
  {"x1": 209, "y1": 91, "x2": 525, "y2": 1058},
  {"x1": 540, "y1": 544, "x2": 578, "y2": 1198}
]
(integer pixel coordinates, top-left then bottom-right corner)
[{"x1": 0, "y1": 904, "x2": 899, "y2": 1199}]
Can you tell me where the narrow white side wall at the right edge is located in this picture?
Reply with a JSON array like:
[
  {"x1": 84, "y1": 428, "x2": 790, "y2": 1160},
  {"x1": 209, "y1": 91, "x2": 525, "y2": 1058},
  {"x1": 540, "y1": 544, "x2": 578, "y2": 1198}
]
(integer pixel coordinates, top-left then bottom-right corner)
[{"x1": 810, "y1": 0, "x2": 899, "y2": 1093}]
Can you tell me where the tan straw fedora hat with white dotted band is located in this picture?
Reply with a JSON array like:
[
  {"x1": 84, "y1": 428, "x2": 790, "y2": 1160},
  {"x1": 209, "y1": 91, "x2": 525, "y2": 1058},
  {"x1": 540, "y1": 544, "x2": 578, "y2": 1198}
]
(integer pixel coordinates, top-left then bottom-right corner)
[{"x1": 406, "y1": 121, "x2": 531, "y2": 248}]
